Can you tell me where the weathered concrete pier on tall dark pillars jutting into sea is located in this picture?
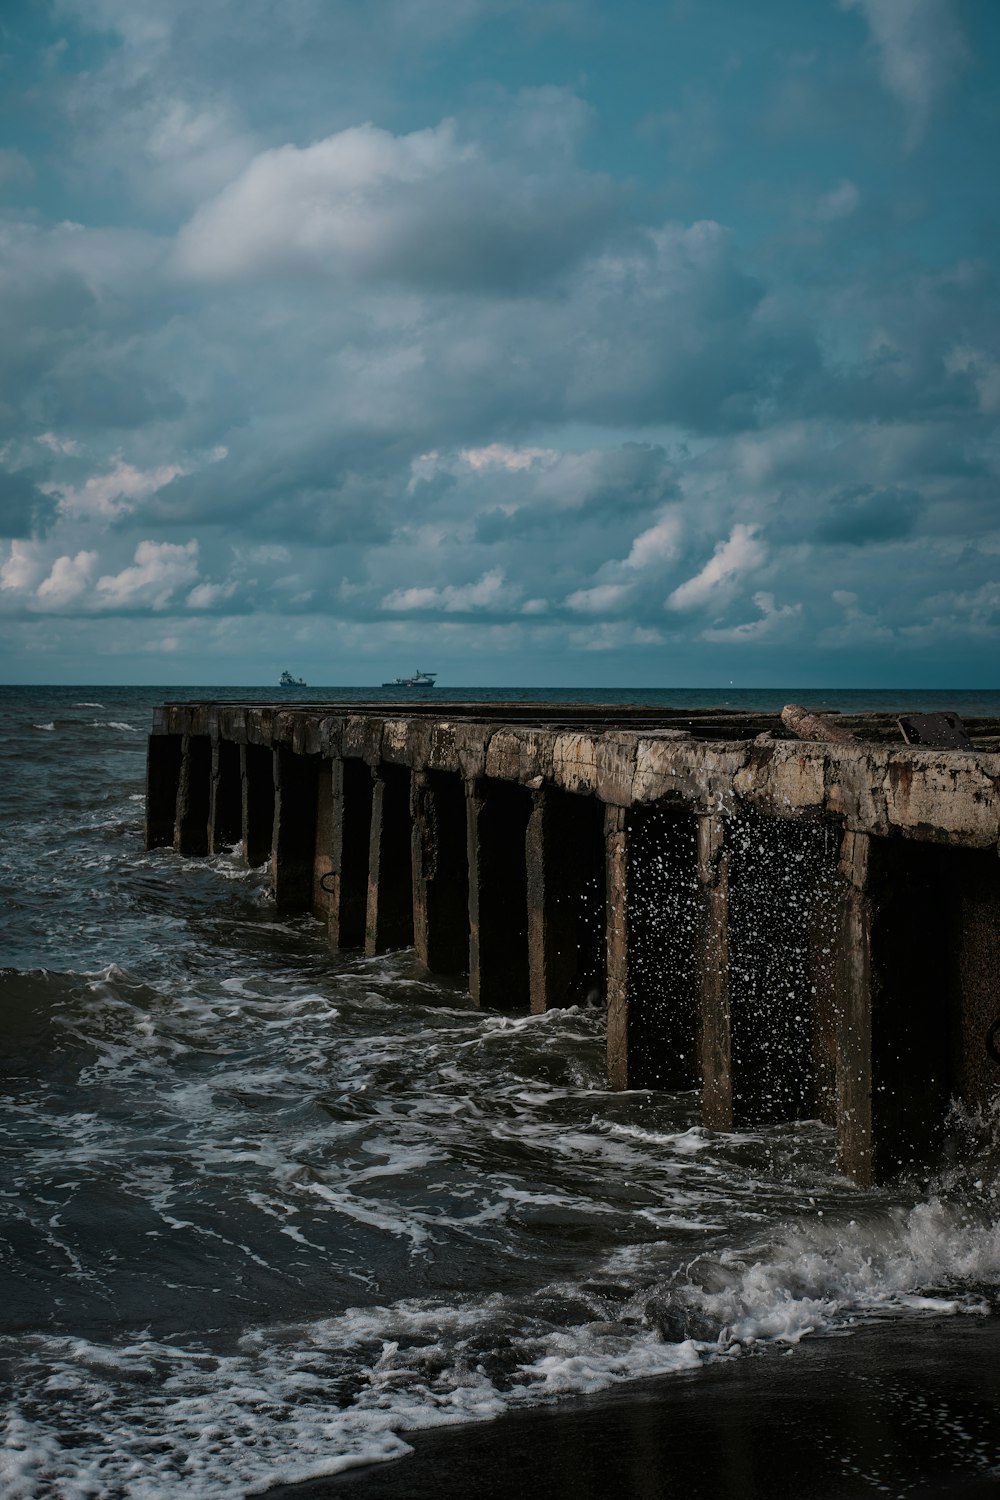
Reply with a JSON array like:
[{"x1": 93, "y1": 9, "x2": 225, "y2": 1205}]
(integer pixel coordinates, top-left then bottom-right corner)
[{"x1": 145, "y1": 701, "x2": 1000, "y2": 1182}]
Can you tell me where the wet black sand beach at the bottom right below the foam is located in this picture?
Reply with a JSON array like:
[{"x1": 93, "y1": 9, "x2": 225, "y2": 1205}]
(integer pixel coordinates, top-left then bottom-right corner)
[{"x1": 267, "y1": 1317, "x2": 1000, "y2": 1500}]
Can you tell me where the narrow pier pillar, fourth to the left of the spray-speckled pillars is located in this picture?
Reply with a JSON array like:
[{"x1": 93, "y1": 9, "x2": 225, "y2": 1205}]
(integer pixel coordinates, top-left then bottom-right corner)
[{"x1": 364, "y1": 765, "x2": 414, "y2": 956}]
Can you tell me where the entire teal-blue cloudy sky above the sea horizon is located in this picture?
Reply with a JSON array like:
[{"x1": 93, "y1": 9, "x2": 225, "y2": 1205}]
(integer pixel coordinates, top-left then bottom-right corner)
[{"x1": 0, "y1": 0, "x2": 1000, "y2": 687}]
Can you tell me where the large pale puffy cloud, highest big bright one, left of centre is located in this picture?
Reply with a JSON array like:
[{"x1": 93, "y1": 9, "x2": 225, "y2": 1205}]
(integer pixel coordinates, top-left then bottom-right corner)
[{"x1": 175, "y1": 106, "x2": 613, "y2": 290}]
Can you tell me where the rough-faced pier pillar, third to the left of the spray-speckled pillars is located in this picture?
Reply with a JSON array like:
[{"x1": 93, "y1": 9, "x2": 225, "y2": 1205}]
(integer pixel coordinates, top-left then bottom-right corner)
[{"x1": 412, "y1": 771, "x2": 469, "y2": 974}]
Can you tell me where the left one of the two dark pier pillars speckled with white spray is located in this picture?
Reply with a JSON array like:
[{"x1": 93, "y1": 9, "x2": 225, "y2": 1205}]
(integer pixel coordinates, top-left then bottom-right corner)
[{"x1": 606, "y1": 807, "x2": 700, "y2": 1089}]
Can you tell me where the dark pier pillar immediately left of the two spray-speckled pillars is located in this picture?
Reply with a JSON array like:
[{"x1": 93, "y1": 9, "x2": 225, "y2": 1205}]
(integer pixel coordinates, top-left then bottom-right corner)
[{"x1": 525, "y1": 788, "x2": 606, "y2": 1013}]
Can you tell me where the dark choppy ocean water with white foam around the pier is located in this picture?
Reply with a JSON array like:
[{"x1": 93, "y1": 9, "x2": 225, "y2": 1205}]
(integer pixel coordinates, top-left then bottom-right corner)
[{"x1": 0, "y1": 687, "x2": 1000, "y2": 1500}]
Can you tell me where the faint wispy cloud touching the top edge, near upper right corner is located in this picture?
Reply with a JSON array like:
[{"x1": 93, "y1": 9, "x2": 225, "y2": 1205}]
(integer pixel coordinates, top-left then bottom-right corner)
[{"x1": 841, "y1": 0, "x2": 970, "y2": 146}]
